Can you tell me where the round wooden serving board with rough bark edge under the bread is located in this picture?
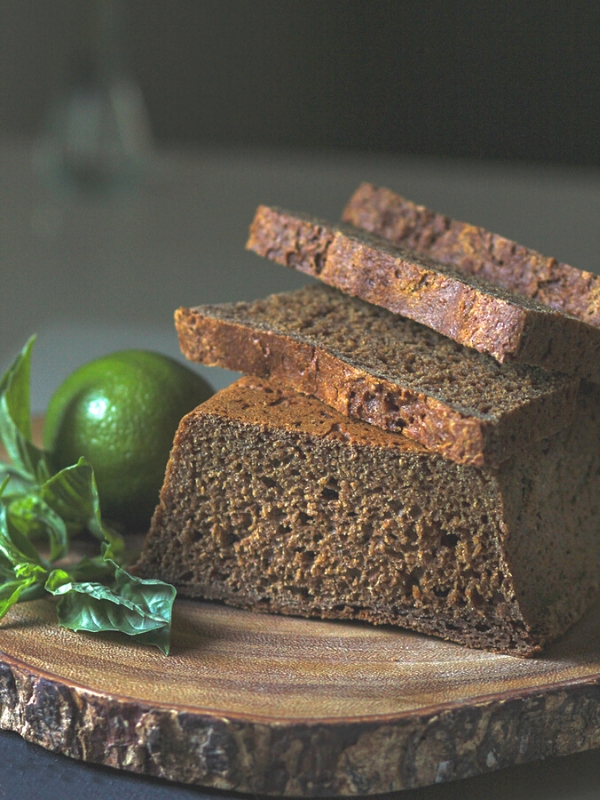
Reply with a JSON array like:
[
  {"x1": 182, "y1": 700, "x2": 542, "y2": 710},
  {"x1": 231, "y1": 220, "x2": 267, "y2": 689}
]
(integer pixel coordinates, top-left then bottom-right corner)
[{"x1": 0, "y1": 600, "x2": 600, "y2": 796}]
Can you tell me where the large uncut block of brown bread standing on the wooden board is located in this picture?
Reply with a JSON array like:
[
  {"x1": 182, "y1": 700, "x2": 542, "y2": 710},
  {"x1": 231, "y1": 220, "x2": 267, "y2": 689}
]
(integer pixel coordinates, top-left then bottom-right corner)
[{"x1": 136, "y1": 378, "x2": 600, "y2": 656}]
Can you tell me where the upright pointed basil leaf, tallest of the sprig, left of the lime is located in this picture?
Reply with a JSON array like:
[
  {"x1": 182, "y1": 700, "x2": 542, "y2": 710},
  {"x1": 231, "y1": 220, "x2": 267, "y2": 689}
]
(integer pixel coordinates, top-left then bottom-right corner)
[{"x1": 0, "y1": 337, "x2": 44, "y2": 478}]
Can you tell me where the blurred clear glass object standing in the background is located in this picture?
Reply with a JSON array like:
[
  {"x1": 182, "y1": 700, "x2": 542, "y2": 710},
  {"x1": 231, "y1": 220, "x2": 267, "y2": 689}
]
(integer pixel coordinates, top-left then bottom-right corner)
[{"x1": 34, "y1": 0, "x2": 151, "y2": 193}]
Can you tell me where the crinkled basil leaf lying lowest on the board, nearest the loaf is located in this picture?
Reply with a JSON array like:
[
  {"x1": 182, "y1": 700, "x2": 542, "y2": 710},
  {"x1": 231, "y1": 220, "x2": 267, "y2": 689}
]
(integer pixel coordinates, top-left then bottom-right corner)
[{"x1": 45, "y1": 560, "x2": 176, "y2": 655}]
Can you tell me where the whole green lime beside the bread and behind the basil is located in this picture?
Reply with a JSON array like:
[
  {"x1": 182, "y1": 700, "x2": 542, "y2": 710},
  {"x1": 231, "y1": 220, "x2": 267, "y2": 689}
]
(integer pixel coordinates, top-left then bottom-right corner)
[{"x1": 44, "y1": 350, "x2": 213, "y2": 530}]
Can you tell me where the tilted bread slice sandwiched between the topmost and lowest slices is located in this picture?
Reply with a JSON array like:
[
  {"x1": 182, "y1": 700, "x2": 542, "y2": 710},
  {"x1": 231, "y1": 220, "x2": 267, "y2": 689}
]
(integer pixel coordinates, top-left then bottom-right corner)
[{"x1": 247, "y1": 206, "x2": 600, "y2": 382}]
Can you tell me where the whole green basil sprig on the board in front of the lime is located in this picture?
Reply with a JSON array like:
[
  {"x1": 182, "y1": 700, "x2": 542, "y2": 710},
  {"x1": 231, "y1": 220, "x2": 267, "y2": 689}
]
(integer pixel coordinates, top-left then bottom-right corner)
[{"x1": 0, "y1": 338, "x2": 176, "y2": 654}]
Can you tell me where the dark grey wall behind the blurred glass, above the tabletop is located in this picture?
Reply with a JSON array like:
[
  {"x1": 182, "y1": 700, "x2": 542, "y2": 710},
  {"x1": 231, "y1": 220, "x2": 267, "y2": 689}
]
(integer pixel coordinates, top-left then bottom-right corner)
[{"x1": 0, "y1": 0, "x2": 600, "y2": 166}]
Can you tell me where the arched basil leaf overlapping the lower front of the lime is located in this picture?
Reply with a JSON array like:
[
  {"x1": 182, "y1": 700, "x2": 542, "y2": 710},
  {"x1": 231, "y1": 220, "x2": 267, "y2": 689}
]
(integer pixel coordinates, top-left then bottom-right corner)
[{"x1": 40, "y1": 458, "x2": 125, "y2": 556}]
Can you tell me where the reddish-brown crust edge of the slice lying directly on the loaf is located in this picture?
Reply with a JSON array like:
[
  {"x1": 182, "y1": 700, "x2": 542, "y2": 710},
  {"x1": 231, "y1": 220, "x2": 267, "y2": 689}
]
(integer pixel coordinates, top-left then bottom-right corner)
[{"x1": 175, "y1": 287, "x2": 577, "y2": 466}]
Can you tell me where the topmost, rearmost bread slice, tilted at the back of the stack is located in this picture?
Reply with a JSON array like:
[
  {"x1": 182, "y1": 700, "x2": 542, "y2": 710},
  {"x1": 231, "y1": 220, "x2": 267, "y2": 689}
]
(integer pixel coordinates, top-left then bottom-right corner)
[{"x1": 343, "y1": 183, "x2": 600, "y2": 327}]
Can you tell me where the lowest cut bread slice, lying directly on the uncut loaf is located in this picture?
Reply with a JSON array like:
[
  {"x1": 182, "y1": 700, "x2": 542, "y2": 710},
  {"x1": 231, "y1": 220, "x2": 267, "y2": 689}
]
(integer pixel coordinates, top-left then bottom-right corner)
[{"x1": 175, "y1": 284, "x2": 578, "y2": 465}]
